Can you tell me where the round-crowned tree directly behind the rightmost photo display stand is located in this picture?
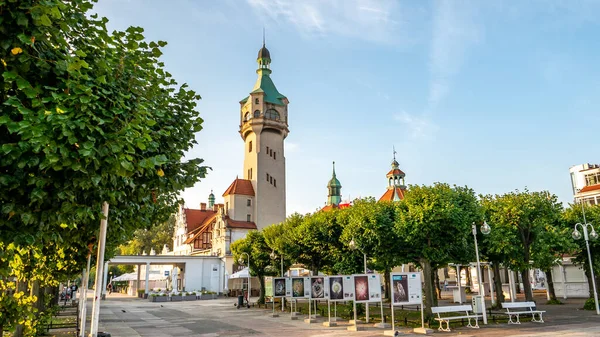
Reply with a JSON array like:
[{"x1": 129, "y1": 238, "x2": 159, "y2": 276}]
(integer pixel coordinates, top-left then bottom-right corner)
[{"x1": 395, "y1": 183, "x2": 482, "y2": 314}]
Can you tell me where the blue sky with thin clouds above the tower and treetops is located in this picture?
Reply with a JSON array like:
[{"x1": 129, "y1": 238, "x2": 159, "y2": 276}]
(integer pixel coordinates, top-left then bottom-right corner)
[{"x1": 95, "y1": 0, "x2": 600, "y2": 214}]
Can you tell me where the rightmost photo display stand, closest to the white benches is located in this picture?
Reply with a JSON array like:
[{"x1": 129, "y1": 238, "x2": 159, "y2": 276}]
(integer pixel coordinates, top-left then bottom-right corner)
[{"x1": 385, "y1": 272, "x2": 433, "y2": 336}]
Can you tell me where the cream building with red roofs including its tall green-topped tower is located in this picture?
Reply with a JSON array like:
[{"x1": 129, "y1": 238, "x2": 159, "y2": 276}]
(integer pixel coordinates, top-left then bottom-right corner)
[{"x1": 172, "y1": 44, "x2": 289, "y2": 290}]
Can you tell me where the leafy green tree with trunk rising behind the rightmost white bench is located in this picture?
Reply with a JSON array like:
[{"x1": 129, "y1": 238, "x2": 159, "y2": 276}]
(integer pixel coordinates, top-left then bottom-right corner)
[{"x1": 482, "y1": 190, "x2": 564, "y2": 301}]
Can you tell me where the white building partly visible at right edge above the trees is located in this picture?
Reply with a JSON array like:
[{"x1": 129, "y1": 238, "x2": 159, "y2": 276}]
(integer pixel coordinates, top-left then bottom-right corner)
[{"x1": 569, "y1": 164, "x2": 600, "y2": 205}]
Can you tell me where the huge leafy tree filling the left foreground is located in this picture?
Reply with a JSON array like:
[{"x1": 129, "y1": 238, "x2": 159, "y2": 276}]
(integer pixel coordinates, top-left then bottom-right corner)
[{"x1": 0, "y1": 0, "x2": 206, "y2": 334}]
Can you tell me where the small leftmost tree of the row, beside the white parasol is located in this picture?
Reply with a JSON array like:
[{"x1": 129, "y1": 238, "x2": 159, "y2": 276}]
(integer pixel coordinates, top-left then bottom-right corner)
[{"x1": 231, "y1": 231, "x2": 279, "y2": 304}]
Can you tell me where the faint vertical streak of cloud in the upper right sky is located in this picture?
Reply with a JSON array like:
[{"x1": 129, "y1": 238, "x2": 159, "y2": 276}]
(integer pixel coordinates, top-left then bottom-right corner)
[{"x1": 428, "y1": 0, "x2": 483, "y2": 110}]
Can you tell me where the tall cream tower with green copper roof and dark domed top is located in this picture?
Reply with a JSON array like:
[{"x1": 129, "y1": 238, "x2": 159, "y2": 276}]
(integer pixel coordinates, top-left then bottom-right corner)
[{"x1": 240, "y1": 41, "x2": 289, "y2": 230}]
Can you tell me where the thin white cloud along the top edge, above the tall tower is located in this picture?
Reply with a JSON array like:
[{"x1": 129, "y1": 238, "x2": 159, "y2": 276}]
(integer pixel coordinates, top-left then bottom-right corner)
[{"x1": 247, "y1": 0, "x2": 400, "y2": 43}]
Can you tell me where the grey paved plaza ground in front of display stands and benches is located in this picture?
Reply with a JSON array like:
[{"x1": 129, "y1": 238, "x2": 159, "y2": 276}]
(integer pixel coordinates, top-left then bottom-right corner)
[{"x1": 88, "y1": 294, "x2": 600, "y2": 337}]
